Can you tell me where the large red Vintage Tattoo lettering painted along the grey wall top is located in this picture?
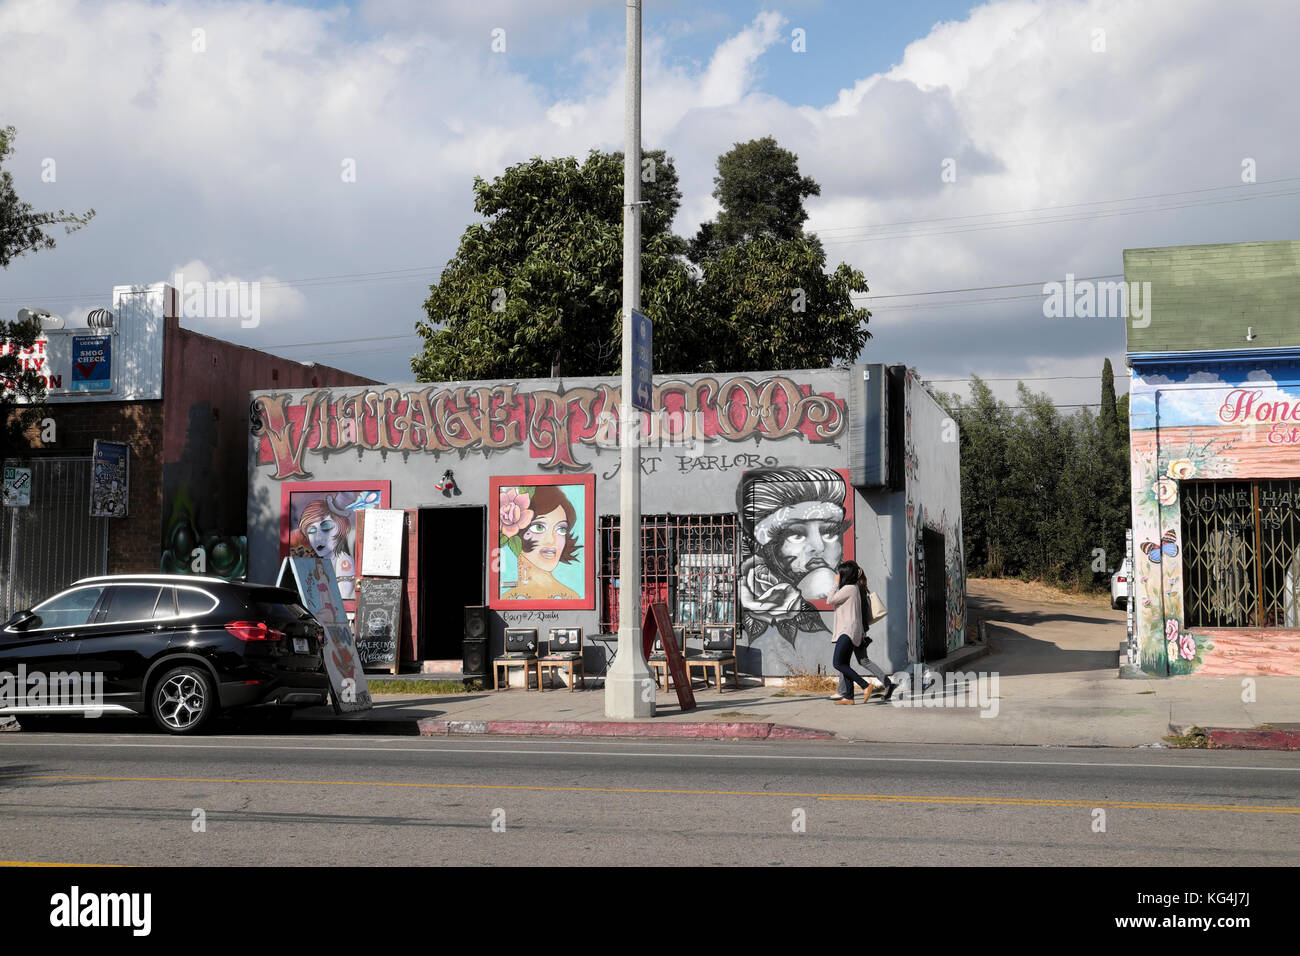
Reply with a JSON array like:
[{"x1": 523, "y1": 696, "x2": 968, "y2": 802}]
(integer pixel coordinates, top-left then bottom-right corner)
[{"x1": 251, "y1": 375, "x2": 848, "y2": 481}]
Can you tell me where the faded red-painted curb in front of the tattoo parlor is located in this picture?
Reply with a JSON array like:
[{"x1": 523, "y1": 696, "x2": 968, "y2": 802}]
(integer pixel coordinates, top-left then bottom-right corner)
[{"x1": 419, "y1": 717, "x2": 836, "y2": 740}]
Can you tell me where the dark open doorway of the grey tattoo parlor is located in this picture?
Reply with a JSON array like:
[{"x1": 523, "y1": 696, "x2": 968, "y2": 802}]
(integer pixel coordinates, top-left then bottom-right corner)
[{"x1": 417, "y1": 507, "x2": 488, "y2": 661}]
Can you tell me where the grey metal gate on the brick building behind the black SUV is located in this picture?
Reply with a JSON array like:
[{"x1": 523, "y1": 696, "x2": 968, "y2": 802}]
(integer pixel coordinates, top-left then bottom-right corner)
[{"x1": 0, "y1": 458, "x2": 108, "y2": 620}]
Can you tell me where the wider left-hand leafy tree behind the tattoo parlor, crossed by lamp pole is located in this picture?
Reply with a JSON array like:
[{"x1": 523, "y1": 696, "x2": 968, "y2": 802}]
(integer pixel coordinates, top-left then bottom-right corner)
[{"x1": 411, "y1": 150, "x2": 696, "y2": 381}]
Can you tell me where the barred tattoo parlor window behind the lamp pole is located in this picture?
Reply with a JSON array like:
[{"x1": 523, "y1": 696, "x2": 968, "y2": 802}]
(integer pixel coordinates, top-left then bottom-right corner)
[{"x1": 599, "y1": 515, "x2": 738, "y2": 633}]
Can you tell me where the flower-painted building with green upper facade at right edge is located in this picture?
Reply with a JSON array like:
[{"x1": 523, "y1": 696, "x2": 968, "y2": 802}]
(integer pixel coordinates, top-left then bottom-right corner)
[{"x1": 1125, "y1": 241, "x2": 1300, "y2": 676}]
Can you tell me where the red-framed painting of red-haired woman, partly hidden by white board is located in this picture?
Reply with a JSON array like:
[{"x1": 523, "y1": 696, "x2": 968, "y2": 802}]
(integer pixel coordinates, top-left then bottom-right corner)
[{"x1": 280, "y1": 481, "x2": 391, "y2": 613}]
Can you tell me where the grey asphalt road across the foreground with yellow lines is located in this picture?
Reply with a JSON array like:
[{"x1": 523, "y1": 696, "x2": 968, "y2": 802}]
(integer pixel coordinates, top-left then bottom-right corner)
[{"x1": 0, "y1": 732, "x2": 1300, "y2": 866}]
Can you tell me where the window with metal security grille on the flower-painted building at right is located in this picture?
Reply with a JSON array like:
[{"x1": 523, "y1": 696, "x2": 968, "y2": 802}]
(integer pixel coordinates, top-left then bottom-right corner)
[{"x1": 1185, "y1": 479, "x2": 1300, "y2": 628}]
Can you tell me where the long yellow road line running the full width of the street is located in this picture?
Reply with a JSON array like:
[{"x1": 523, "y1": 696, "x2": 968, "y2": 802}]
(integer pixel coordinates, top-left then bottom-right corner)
[{"x1": 0, "y1": 774, "x2": 1300, "y2": 814}]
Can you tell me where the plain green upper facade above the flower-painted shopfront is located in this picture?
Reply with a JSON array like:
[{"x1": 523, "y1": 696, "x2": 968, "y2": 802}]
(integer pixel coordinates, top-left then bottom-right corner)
[{"x1": 1125, "y1": 239, "x2": 1300, "y2": 352}]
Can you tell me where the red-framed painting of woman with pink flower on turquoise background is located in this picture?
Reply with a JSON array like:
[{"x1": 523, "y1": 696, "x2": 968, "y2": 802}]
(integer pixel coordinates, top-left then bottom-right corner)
[{"x1": 488, "y1": 475, "x2": 595, "y2": 610}]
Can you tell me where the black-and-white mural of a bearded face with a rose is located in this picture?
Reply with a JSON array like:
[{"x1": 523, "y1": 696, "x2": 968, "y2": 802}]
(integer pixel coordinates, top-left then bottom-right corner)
[{"x1": 736, "y1": 467, "x2": 854, "y2": 648}]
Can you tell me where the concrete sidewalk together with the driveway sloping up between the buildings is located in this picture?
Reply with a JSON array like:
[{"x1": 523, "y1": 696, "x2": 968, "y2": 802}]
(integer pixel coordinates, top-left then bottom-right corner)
[{"x1": 295, "y1": 580, "x2": 1300, "y2": 747}]
